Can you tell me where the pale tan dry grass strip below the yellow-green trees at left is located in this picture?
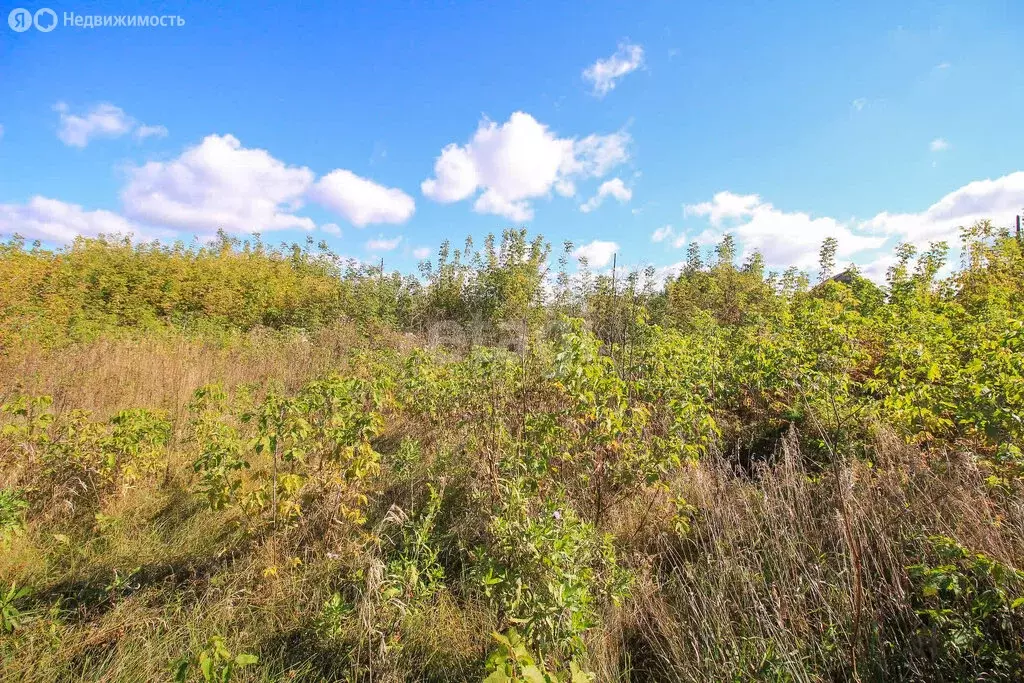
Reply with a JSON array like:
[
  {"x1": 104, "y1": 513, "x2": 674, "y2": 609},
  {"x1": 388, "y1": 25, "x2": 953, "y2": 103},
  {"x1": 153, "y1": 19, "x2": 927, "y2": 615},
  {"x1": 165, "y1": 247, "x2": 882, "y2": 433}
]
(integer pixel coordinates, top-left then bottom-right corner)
[{"x1": 0, "y1": 322, "x2": 412, "y2": 419}]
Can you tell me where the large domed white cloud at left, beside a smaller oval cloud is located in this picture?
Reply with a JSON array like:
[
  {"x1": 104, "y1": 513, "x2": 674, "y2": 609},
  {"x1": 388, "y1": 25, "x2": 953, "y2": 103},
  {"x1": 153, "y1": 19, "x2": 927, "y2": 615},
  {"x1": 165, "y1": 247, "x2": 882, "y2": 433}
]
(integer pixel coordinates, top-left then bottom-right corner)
[{"x1": 121, "y1": 135, "x2": 314, "y2": 232}]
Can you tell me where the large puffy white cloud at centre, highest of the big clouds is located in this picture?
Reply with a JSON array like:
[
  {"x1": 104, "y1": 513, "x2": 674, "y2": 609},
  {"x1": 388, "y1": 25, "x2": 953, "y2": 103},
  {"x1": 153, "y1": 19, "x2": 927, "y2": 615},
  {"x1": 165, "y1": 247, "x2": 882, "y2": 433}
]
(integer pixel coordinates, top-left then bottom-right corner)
[{"x1": 420, "y1": 112, "x2": 630, "y2": 221}]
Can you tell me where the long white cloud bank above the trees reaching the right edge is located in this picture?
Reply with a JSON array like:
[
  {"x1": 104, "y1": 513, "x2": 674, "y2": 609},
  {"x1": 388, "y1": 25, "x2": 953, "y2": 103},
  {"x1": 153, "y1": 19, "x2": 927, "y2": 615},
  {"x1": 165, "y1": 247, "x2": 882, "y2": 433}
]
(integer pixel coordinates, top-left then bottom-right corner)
[{"x1": 679, "y1": 171, "x2": 1024, "y2": 268}]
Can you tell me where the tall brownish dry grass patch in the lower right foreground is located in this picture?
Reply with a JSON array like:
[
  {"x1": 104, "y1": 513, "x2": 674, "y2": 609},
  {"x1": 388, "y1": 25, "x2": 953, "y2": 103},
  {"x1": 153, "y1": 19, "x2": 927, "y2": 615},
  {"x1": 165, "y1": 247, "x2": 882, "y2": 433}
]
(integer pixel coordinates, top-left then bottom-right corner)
[{"x1": 594, "y1": 428, "x2": 1024, "y2": 681}]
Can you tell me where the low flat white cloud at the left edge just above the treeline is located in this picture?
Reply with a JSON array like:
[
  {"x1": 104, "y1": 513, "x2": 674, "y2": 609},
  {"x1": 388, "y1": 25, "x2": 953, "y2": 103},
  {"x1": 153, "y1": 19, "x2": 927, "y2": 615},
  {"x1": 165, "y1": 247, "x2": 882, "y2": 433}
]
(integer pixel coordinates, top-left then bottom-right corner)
[{"x1": 0, "y1": 196, "x2": 139, "y2": 243}]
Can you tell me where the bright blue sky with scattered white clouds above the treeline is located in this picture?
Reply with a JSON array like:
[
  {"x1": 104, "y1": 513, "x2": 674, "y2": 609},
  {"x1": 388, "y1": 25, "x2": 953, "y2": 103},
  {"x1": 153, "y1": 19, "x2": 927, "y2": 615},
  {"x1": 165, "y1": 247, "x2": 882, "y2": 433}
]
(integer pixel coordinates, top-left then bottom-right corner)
[{"x1": 0, "y1": 0, "x2": 1024, "y2": 274}]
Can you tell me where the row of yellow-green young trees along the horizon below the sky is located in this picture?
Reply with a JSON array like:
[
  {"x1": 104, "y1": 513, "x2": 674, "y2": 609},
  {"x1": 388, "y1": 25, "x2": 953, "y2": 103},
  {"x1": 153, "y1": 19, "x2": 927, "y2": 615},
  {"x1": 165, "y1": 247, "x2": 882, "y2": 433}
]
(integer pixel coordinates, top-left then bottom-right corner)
[{"x1": 0, "y1": 223, "x2": 1021, "y2": 346}]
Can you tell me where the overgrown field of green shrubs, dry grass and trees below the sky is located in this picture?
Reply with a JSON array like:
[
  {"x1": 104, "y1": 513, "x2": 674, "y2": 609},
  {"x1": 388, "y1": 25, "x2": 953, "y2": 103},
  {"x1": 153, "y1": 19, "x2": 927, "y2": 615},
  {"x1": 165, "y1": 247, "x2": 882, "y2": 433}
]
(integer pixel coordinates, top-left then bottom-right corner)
[{"x1": 0, "y1": 223, "x2": 1024, "y2": 683}]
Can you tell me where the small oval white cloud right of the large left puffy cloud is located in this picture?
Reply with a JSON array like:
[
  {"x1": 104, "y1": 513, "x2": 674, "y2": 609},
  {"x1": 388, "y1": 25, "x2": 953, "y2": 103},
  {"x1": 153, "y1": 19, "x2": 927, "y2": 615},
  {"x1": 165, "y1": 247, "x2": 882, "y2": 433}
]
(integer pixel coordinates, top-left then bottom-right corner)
[{"x1": 309, "y1": 169, "x2": 416, "y2": 227}]
